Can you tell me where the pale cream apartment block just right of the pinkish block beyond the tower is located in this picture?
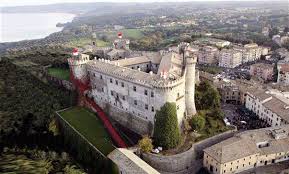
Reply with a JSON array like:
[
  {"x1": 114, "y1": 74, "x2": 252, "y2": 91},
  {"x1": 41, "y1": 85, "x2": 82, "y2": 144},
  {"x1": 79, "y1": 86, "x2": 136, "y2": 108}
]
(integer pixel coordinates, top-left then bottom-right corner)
[{"x1": 219, "y1": 49, "x2": 242, "y2": 68}]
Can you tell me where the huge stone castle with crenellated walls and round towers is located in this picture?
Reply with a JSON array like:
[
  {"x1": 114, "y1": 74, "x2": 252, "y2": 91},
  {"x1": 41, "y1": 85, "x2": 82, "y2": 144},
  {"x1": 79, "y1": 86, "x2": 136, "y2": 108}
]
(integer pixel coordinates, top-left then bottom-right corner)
[{"x1": 68, "y1": 33, "x2": 197, "y2": 135}]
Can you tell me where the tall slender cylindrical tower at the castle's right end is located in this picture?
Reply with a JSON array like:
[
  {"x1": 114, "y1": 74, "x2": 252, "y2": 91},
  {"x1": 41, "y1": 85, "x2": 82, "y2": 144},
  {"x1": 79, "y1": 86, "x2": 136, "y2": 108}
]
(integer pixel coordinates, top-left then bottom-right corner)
[{"x1": 185, "y1": 48, "x2": 197, "y2": 117}]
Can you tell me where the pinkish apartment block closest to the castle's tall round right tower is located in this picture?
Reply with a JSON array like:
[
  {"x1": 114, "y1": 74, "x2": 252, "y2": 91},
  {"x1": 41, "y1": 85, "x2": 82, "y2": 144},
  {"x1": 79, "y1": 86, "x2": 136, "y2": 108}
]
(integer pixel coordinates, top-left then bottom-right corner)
[{"x1": 198, "y1": 46, "x2": 219, "y2": 65}]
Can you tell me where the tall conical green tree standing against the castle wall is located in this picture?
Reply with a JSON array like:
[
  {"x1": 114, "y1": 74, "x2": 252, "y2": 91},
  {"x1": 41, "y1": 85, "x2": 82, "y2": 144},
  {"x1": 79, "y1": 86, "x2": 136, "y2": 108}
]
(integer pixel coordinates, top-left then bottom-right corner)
[{"x1": 154, "y1": 102, "x2": 180, "y2": 149}]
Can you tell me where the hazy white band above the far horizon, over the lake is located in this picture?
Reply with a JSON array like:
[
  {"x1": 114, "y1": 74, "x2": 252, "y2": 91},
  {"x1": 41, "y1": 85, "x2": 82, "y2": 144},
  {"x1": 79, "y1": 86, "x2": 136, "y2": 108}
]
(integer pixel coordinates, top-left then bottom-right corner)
[{"x1": 0, "y1": 0, "x2": 280, "y2": 7}]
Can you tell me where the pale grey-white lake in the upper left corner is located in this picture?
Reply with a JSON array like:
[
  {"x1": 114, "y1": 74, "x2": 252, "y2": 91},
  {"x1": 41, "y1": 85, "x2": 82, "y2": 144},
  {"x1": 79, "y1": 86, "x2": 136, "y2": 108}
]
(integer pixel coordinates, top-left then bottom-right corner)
[{"x1": 0, "y1": 13, "x2": 75, "y2": 42}]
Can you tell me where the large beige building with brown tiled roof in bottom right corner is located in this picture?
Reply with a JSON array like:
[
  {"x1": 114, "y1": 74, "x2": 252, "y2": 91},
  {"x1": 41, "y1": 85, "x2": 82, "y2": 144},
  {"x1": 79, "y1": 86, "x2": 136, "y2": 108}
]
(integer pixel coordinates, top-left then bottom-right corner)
[{"x1": 203, "y1": 125, "x2": 289, "y2": 174}]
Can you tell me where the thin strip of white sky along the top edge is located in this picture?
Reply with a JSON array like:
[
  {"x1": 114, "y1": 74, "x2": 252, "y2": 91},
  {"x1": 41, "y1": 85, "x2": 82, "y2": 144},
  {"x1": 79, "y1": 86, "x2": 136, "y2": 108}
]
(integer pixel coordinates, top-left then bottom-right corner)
[{"x1": 0, "y1": 0, "x2": 270, "y2": 7}]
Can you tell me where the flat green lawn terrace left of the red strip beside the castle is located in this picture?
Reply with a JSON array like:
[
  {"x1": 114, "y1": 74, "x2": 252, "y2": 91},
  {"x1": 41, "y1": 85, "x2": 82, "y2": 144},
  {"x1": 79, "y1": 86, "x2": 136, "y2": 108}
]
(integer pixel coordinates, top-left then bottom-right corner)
[{"x1": 59, "y1": 107, "x2": 115, "y2": 155}]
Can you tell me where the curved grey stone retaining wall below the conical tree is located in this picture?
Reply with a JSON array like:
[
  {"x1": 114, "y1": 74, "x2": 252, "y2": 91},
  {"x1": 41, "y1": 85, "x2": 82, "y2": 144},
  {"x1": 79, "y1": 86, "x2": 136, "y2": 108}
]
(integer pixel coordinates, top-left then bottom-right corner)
[{"x1": 142, "y1": 129, "x2": 236, "y2": 174}]
